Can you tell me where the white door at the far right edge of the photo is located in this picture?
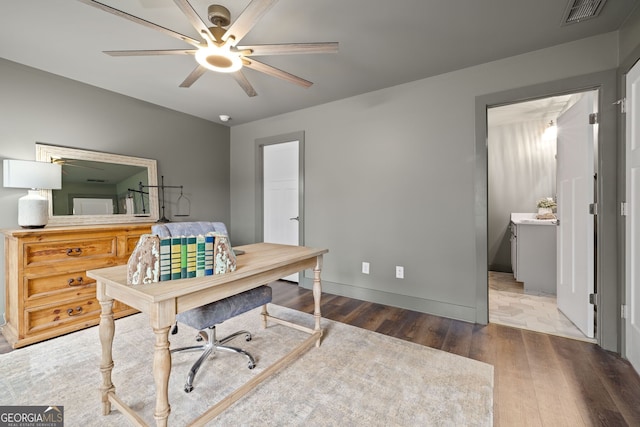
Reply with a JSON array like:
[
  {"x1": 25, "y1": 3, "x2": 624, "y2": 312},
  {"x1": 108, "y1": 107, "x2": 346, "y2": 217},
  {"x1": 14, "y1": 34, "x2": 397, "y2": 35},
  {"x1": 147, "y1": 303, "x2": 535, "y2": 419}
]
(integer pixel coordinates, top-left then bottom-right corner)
[{"x1": 625, "y1": 62, "x2": 640, "y2": 372}]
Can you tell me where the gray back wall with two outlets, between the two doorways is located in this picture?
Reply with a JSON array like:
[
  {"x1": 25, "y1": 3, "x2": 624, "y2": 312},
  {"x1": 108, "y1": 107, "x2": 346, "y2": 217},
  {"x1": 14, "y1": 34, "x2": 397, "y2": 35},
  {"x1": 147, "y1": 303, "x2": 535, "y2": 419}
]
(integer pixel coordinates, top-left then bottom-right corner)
[{"x1": 231, "y1": 33, "x2": 618, "y2": 322}]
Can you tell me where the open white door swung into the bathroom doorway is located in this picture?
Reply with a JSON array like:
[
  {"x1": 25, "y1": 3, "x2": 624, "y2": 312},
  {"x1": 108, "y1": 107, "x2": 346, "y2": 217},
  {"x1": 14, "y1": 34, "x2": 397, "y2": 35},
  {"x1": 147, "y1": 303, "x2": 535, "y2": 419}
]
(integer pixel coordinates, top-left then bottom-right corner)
[{"x1": 556, "y1": 91, "x2": 597, "y2": 338}]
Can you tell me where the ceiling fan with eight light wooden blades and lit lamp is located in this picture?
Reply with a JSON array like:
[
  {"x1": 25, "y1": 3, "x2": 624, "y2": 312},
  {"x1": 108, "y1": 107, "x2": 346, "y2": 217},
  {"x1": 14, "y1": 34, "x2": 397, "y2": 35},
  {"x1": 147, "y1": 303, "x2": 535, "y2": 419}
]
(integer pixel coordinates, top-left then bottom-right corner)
[{"x1": 78, "y1": 0, "x2": 338, "y2": 96}]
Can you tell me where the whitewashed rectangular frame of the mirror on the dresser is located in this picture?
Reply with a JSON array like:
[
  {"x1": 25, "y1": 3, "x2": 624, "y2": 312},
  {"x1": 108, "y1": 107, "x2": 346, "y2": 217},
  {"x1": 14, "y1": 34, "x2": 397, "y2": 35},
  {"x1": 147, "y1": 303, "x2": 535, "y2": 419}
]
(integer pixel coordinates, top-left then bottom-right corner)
[{"x1": 36, "y1": 142, "x2": 160, "y2": 226}]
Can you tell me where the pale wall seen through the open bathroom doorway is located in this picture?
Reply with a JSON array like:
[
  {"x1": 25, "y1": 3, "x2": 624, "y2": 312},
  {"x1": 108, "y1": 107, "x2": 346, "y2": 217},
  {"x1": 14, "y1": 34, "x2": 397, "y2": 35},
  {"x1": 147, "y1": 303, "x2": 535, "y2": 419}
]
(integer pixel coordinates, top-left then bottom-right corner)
[{"x1": 487, "y1": 118, "x2": 556, "y2": 273}]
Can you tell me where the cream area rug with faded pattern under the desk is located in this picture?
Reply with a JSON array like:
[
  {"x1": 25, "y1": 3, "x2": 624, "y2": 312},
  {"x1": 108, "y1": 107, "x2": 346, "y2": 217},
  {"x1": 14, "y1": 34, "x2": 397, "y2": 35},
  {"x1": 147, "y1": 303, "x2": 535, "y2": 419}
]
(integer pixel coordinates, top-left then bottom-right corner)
[{"x1": 0, "y1": 305, "x2": 493, "y2": 427}]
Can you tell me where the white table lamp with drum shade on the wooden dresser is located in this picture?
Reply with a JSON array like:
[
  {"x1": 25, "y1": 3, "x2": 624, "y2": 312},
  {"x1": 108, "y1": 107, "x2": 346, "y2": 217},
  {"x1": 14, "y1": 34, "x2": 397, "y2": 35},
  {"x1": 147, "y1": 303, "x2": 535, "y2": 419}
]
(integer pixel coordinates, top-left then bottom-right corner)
[{"x1": 2, "y1": 159, "x2": 62, "y2": 228}]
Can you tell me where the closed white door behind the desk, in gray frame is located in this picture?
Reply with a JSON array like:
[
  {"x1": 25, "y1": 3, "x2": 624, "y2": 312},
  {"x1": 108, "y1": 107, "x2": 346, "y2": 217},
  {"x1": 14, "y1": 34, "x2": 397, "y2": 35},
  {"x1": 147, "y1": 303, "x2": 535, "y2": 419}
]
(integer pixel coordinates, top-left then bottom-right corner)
[{"x1": 263, "y1": 141, "x2": 300, "y2": 283}]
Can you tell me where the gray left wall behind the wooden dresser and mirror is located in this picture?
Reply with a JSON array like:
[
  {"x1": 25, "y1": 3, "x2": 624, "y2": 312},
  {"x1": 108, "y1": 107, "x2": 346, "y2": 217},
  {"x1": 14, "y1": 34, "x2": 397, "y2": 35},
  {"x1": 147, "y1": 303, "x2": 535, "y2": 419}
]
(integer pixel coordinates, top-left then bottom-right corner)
[{"x1": 0, "y1": 59, "x2": 230, "y2": 323}]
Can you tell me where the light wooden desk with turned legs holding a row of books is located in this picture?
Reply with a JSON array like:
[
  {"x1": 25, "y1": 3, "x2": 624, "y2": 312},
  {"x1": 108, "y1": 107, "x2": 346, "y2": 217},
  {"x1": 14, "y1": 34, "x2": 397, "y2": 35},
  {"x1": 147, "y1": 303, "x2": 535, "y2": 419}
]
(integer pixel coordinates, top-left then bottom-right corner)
[{"x1": 87, "y1": 243, "x2": 328, "y2": 426}]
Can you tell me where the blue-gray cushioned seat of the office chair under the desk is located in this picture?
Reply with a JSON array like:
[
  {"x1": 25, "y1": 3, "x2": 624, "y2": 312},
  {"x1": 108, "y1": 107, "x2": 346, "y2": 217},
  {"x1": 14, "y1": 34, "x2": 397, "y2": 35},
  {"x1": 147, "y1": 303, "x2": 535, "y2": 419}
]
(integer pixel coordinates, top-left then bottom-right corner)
[{"x1": 176, "y1": 286, "x2": 271, "y2": 330}]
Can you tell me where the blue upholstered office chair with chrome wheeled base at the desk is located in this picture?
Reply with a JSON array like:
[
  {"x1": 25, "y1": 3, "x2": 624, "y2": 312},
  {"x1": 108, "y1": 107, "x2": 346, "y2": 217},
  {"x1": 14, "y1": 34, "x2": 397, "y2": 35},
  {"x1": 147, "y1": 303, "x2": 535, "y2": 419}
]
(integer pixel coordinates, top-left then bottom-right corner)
[{"x1": 151, "y1": 221, "x2": 271, "y2": 393}]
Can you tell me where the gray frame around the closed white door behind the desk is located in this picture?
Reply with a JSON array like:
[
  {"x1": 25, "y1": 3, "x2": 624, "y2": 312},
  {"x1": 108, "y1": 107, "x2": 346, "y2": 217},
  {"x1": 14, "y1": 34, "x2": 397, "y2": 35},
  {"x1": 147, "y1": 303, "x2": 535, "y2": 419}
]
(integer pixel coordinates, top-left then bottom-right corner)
[{"x1": 255, "y1": 131, "x2": 305, "y2": 247}]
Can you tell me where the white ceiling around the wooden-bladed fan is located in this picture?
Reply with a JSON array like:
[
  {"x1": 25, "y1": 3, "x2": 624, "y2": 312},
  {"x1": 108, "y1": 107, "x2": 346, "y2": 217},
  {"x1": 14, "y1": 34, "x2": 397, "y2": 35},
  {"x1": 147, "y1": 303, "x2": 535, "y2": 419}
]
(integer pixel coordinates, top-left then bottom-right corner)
[{"x1": 0, "y1": 0, "x2": 640, "y2": 125}]
